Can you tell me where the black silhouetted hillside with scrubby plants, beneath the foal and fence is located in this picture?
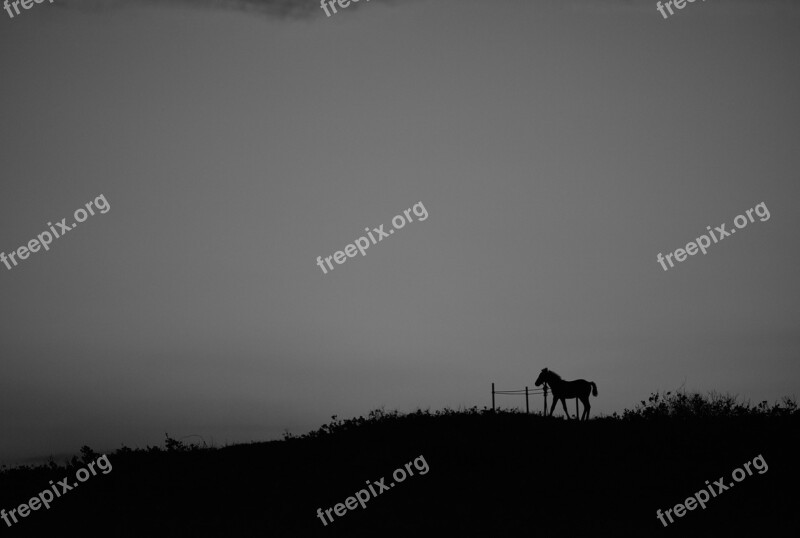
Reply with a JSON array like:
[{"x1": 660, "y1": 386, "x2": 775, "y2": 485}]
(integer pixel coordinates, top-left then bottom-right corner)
[{"x1": 0, "y1": 391, "x2": 800, "y2": 537}]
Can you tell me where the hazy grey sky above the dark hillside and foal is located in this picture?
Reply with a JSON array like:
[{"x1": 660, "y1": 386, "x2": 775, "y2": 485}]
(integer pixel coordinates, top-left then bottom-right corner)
[{"x1": 0, "y1": 0, "x2": 800, "y2": 464}]
